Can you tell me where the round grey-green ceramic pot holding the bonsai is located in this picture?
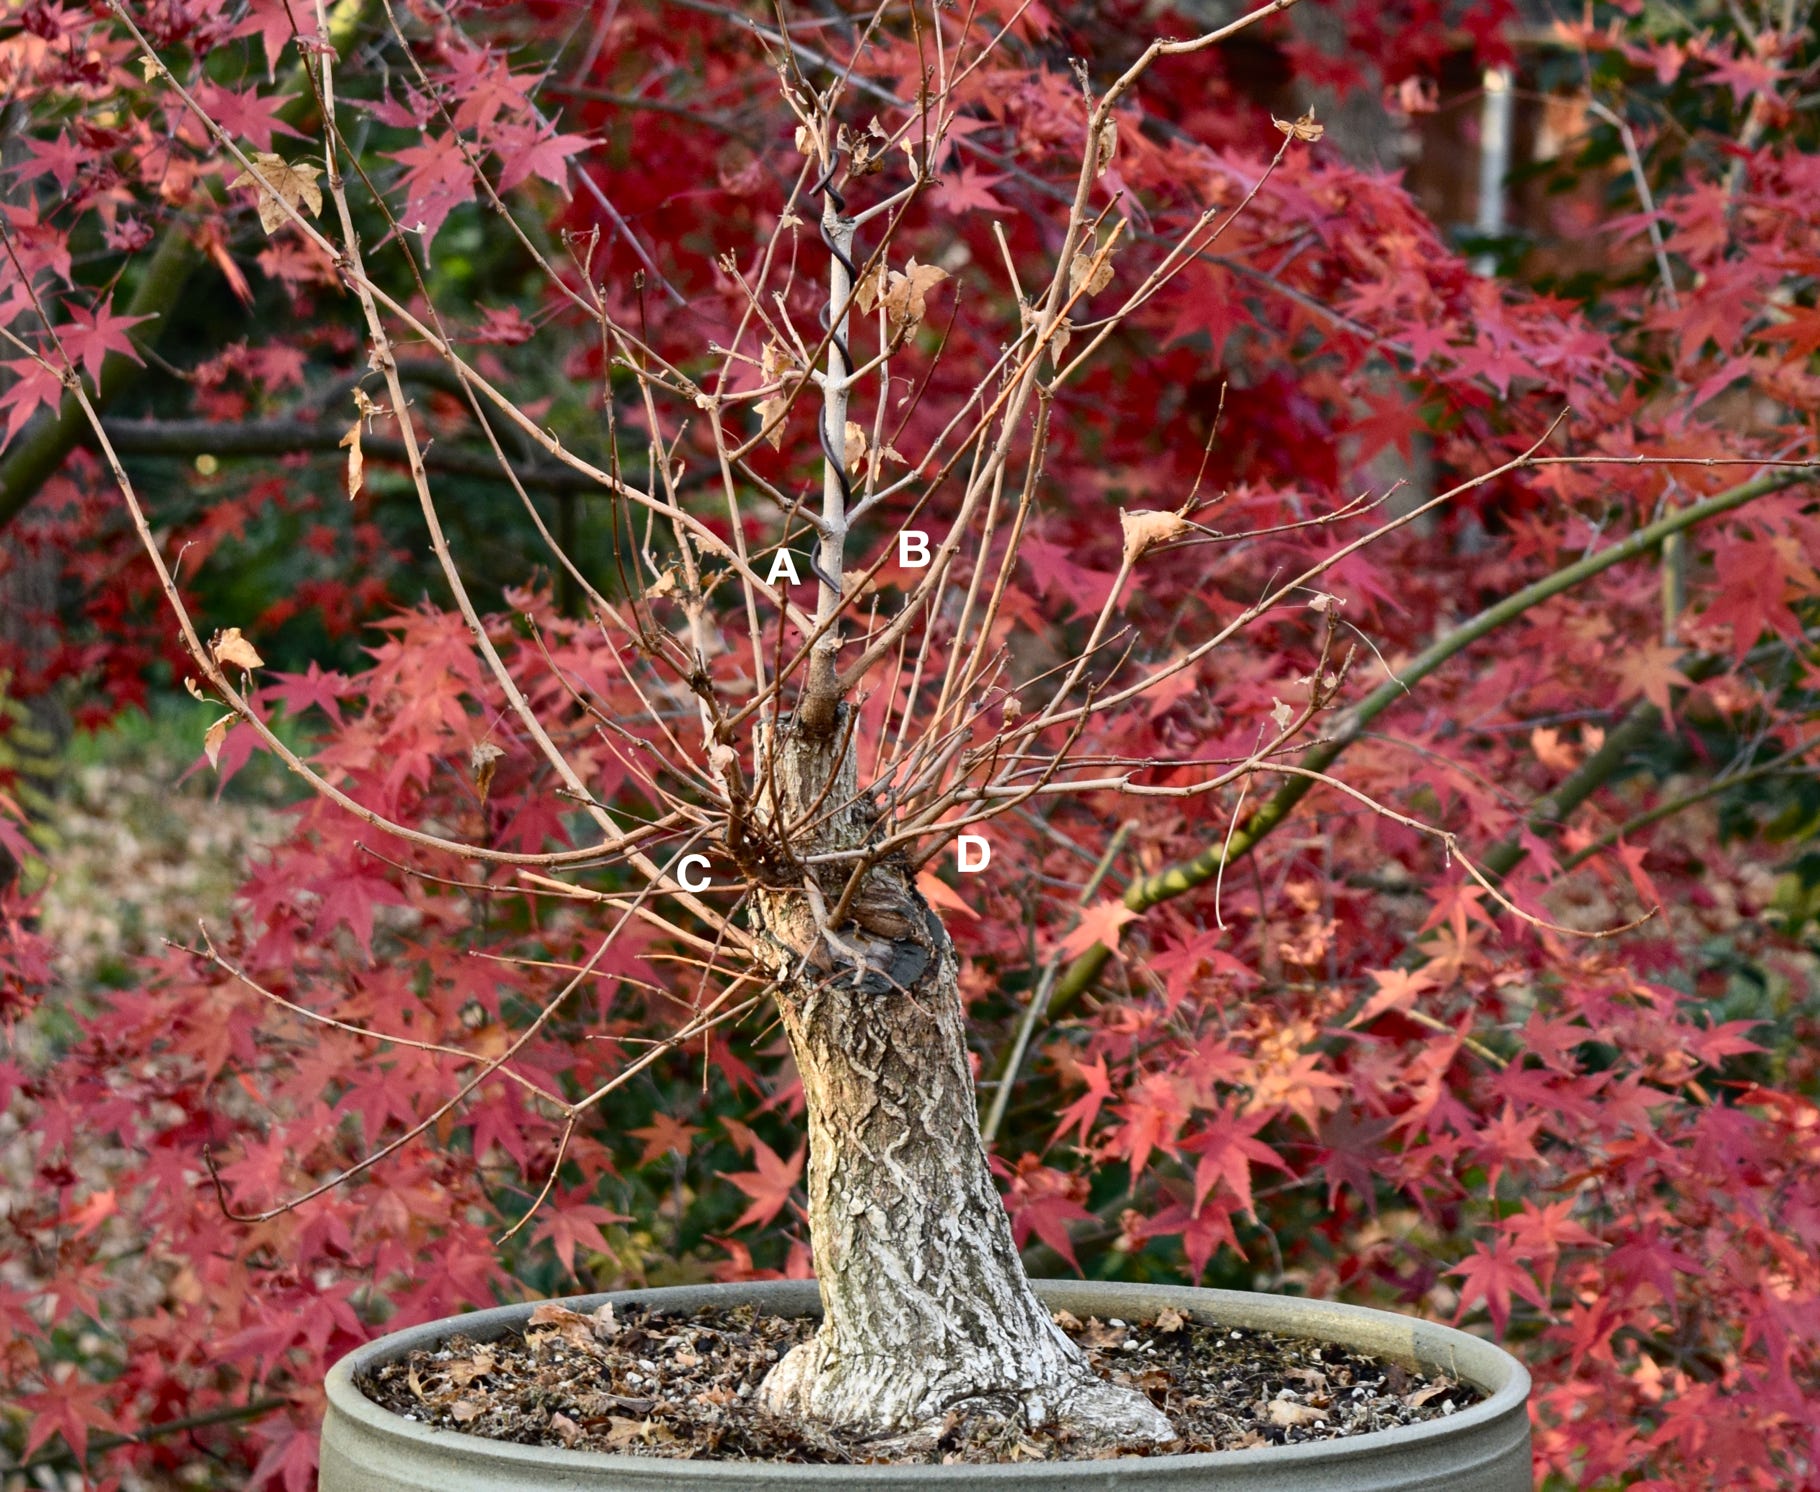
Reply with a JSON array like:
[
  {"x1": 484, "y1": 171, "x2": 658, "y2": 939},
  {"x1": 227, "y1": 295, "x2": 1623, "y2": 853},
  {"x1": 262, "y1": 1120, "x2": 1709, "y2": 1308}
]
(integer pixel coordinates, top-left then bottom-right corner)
[{"x1": 320, "y1": 1281, "x2": 1534, "y2": 1492}]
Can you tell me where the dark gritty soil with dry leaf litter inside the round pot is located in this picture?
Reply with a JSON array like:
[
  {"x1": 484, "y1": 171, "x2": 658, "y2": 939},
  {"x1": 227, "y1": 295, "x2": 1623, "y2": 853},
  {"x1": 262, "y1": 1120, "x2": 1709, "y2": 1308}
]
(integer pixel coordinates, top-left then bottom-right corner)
[{"x1": 359, "y1": 1305, "x2": 1483, "y2": 1463}]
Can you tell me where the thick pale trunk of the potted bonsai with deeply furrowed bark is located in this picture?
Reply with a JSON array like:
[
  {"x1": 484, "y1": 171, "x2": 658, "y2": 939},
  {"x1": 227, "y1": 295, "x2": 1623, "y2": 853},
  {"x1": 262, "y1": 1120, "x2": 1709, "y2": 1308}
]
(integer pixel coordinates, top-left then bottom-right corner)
[{"x1": 757, "y1": 706, "x2": 1174, "y2": 1447}]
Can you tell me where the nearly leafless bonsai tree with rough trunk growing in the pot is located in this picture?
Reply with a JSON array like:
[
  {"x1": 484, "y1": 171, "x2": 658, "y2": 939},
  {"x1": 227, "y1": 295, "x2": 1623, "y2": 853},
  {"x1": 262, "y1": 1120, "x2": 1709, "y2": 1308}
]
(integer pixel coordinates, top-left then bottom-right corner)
[{"x1": 64, "y1": 0, "x2": 1375, "y2": 1445}]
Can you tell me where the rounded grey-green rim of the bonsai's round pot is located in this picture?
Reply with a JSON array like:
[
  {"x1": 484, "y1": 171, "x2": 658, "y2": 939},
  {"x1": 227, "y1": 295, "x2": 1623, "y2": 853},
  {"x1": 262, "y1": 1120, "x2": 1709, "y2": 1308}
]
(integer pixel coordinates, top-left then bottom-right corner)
[{"x1": 324, "y1": 1279, "x2": 1531, "y2": 1483}]
